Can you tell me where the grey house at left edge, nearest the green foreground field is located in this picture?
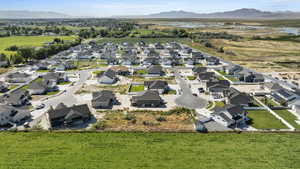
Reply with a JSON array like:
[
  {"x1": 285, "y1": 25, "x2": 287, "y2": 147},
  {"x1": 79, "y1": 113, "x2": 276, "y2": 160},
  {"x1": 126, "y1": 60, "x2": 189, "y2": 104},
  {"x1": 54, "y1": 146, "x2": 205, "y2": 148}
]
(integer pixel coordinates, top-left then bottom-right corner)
[{"x1": 0, "y1": 105, "x2": 31, "y2": 127}]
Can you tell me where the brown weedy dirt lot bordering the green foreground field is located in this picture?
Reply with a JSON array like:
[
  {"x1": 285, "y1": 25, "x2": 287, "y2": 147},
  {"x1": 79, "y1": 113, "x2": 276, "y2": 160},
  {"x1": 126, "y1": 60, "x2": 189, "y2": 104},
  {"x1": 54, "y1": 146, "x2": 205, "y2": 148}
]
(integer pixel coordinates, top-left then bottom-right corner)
[{"x1": 97, "y1": 108, "x2": 194, "y2": 132}]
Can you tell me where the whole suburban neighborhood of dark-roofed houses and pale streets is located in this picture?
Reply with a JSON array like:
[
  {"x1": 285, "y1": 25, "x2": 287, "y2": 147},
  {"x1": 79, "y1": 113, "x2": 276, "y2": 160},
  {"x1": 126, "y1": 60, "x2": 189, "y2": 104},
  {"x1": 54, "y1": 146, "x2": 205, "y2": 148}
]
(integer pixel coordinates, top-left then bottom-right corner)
[{"x1": 0, "y1": 41, "x2": 300, "y2": 132}]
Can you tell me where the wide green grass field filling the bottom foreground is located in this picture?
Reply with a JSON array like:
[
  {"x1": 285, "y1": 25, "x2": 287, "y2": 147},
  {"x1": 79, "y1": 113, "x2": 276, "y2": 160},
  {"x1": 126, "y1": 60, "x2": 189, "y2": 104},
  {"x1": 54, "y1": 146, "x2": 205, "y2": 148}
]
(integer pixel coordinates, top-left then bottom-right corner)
[{"x1": 0, "y1": 132, "x2": 300, "y2": 169}]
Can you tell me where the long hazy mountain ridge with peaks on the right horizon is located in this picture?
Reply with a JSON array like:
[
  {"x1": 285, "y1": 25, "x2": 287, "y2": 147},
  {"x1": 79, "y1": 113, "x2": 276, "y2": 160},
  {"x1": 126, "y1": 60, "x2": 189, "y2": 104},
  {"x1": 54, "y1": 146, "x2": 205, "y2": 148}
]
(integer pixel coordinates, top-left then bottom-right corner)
[{"x1": 113, "y1": 8, "x2": 300, "y2": 19}]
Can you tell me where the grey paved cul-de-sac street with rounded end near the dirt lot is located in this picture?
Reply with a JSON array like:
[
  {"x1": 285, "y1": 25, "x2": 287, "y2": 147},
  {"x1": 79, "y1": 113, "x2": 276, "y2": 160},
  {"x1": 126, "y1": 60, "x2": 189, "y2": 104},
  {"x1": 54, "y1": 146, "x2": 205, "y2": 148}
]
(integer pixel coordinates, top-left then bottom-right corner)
[{"x1": 174, "y1": 70, "x2": 208, "y2": 109}]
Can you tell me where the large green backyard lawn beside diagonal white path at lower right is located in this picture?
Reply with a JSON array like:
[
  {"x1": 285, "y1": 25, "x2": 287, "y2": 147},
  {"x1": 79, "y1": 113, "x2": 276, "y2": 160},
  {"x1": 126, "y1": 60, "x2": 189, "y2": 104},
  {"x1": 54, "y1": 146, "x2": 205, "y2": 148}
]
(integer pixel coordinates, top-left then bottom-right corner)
[{"x1": 248, "y1": 110, "x2": 288, "y2": 129}]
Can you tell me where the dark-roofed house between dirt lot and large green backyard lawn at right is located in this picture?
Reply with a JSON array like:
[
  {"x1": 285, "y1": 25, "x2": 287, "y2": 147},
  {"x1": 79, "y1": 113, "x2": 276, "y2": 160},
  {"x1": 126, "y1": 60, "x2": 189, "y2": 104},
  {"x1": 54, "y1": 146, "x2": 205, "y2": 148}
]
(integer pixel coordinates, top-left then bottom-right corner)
[{"x1": 213, "y1": 105, "x2": 249, "y2": 128}]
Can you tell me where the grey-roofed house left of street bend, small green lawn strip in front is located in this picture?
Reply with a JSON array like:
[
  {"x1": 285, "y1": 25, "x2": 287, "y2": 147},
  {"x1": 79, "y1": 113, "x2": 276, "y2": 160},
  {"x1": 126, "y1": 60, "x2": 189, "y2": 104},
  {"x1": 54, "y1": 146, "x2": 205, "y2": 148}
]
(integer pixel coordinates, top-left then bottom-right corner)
[{"x1": 27, "y1": 80, "x2": 58, "y2": 95}]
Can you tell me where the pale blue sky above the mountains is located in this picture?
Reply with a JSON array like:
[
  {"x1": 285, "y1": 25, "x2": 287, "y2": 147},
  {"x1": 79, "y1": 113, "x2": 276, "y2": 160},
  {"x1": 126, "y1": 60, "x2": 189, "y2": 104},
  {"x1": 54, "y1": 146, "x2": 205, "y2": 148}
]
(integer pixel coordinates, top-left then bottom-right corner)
[{"x1": 0, "y1": 0, "x2": 300, "y2": 17}]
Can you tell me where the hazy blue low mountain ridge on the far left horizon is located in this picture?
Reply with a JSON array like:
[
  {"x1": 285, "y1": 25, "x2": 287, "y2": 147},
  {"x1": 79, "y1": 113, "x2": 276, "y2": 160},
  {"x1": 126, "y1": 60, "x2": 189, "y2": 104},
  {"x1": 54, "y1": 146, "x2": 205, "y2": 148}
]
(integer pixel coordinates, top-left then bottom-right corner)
[{"x1": 0, "y1": 11, "x2": 70, "y2": 19}]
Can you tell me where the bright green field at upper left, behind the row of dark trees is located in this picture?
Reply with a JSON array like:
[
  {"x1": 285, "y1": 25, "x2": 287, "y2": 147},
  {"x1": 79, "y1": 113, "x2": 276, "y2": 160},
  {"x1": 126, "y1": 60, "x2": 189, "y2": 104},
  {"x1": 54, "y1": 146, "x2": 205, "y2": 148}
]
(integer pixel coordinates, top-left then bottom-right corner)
[{"x1": 0, "y1": 36, "x2": 75, "y2": 55}]
